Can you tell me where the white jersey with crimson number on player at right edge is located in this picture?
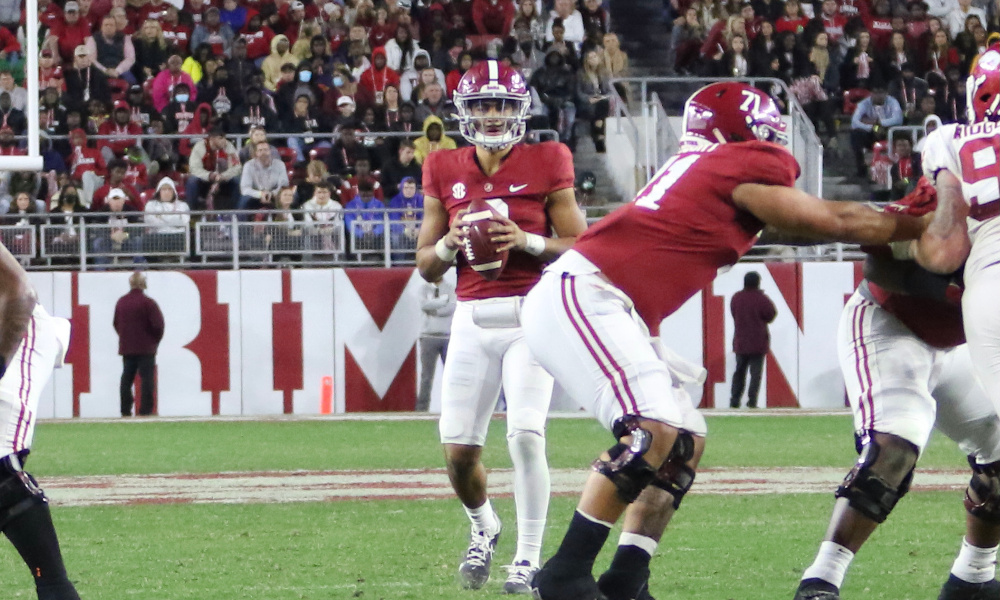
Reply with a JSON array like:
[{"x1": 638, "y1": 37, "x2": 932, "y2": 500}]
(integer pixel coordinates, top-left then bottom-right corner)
[{"x1": 923, "y1": 122, "x2": 1000, "y2": 228}]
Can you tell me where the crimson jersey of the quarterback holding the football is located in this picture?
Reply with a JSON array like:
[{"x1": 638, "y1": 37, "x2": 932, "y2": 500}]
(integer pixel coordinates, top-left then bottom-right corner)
[{"x1": 423, "y1": 142, "x2": 575, "y2": 300}]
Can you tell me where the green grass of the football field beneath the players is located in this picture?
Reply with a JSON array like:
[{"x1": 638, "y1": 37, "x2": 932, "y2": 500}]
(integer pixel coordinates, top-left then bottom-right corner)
[{"x1": 0, "y1": 416, "x2": 966, "y2": 600}]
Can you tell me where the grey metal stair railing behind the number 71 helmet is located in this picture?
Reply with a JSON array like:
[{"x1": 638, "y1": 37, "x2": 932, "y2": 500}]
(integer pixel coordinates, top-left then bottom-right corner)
[{"x1": 612, "y1": 77, "x2": 823, "y2": 196}]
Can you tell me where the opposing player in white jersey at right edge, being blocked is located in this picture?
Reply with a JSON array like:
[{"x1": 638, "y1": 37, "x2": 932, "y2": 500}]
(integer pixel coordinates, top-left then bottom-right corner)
[{"x1": 909, "y1": 49, "x2": 1000, "y2": 600}]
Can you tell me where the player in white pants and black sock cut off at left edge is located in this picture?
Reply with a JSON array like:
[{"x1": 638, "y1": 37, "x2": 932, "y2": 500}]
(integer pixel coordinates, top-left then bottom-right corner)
[{"x1": 0, "y1": 245, "x2": 80, "y2": 600}]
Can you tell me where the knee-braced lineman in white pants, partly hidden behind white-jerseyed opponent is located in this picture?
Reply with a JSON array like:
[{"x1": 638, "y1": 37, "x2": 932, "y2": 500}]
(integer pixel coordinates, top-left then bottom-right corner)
[{"x1": 795, "y1": 178, "x2": 1000, "y2": 600}]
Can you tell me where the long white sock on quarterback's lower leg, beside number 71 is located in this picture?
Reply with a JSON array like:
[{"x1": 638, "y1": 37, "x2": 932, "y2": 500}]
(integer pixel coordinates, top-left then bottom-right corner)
[{"x1": 507, "y1": 431, "x2": 551, "y2": 566}]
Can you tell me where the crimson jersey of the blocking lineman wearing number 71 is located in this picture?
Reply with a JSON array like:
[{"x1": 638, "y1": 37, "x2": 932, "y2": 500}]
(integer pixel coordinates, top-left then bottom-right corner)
[{"x1": 573, "y1": 141, "x2": 799, "y2": 335}]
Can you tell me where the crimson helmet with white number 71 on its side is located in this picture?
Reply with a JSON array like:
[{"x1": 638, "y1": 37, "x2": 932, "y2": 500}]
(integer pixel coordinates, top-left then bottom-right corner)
[{"x1": 684, "y1": 81, "x2": 788, "y2": 144}]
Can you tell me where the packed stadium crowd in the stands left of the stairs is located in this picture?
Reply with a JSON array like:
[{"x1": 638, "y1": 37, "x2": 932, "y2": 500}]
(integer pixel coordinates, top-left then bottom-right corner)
[{"x1": 0, "y1": 0, "x2": 628, "y2": 264}]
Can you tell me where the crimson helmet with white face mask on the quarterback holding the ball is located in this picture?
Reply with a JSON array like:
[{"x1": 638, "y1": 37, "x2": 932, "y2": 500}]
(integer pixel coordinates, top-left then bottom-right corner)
[{"x1": 454, "y1": 60, "x2": 531, "y2": 150}]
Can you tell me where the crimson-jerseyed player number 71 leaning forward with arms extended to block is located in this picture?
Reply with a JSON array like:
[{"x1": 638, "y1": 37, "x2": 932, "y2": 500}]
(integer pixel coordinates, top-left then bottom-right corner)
[{"x1": 522, "y1": 83, "x2": 923, "y2": 600}]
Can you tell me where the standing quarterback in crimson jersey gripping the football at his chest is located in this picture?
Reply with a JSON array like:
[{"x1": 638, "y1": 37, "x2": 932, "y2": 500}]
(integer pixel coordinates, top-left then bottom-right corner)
[{"x1": 417, "y1": 60, "x2": 586, "y2": 594}]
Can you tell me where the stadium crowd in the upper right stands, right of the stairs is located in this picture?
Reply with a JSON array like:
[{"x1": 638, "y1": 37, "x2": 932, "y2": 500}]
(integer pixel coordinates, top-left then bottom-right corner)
[{"x1": 671, "y1": 0, "x2": 984, "y2": 198}]
